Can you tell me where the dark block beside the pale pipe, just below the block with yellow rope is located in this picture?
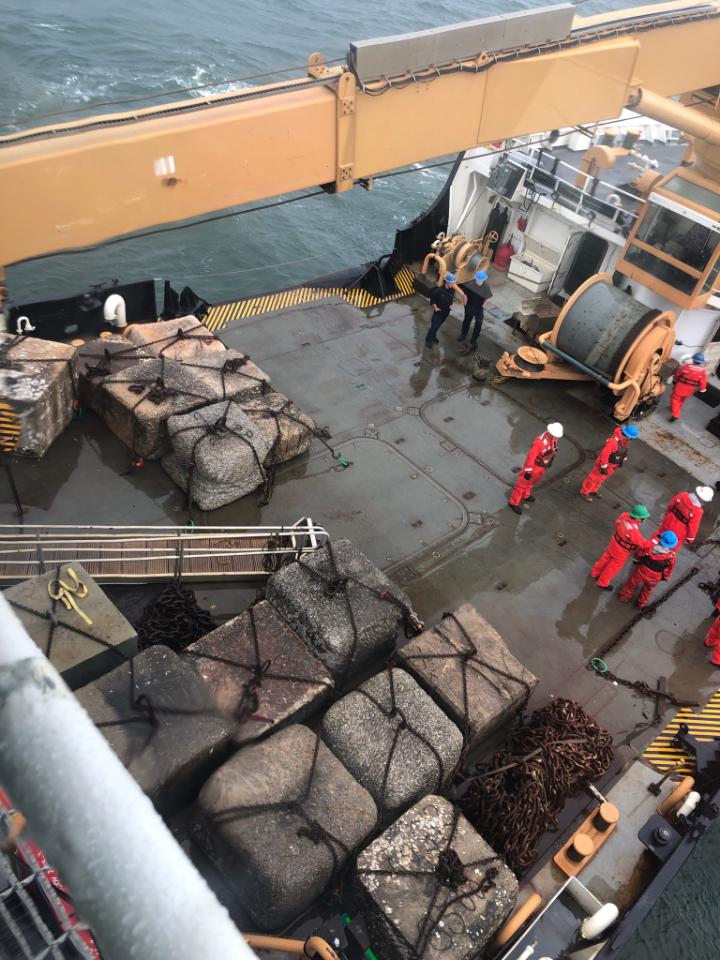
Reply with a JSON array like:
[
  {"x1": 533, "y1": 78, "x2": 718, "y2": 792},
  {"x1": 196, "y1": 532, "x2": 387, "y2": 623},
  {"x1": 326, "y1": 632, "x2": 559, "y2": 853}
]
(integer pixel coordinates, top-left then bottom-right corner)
[{"x1": 76, "y1": 646, "x2": 230, "y2": 814}]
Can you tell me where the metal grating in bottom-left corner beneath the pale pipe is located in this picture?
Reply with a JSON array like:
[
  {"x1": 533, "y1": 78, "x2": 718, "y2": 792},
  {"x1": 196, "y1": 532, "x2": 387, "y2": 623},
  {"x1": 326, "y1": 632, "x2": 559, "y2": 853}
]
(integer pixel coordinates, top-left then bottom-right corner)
[{"x1": 0, "y1": 790, "x2": 101, "y2": 960}]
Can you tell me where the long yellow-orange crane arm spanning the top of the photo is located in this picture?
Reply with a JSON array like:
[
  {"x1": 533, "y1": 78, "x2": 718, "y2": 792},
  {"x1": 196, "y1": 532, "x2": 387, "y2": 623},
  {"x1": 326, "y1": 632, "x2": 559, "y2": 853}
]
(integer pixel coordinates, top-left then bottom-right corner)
[{"x1": 0, "y1": 0, "x2": 720, "y2": 270}]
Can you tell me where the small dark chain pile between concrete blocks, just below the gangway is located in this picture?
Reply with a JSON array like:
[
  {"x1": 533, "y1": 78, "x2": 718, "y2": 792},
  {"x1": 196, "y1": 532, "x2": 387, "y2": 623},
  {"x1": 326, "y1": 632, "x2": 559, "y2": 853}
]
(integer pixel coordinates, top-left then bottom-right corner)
[{"x1": 135, "y1": 583, "x2": 215, "y2": 653}]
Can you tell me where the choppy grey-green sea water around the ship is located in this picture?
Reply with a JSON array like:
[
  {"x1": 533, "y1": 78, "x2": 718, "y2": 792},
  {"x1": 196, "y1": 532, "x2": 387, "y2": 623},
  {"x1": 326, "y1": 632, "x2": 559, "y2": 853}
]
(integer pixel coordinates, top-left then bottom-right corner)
[{"x1": 0, "y1": 0, "x2": 720, "y2": 948}]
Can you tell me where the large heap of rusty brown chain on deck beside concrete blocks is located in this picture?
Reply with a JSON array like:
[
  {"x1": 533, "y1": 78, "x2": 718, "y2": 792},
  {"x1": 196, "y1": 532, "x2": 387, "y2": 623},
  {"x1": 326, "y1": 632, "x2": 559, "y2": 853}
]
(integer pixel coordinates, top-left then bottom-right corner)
[{"x1": 459, "y1": 699, "x2": 613, "y2": 871}]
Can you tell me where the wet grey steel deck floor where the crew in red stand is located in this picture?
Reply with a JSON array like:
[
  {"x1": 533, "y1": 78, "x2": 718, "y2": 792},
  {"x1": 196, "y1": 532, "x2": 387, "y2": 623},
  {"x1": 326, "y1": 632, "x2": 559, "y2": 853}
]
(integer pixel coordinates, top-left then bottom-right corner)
[{"x1": 5, "y1": 278, "x2": 720, "y2": 748}]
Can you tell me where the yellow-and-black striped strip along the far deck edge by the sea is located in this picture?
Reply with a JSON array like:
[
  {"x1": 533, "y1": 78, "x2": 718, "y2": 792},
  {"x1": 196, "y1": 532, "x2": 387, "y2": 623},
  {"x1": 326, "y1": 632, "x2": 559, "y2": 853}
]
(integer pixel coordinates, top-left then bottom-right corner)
[{"x1": 203, "y1": 267, "x2": 415, "y2": 332}]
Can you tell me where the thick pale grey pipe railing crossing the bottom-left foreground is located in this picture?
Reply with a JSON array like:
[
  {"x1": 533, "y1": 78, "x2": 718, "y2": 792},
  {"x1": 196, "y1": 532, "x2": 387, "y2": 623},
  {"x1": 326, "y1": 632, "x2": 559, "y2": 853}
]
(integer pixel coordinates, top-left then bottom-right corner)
[{"x1": 0, "y1": 595, "x2": 255, "y2": 960}]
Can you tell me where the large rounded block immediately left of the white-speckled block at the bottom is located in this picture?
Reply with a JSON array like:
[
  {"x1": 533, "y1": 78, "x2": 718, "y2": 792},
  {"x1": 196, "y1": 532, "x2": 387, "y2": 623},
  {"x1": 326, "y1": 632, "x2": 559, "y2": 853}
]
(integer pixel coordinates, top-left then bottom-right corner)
[{"x1": 196, "y1": 724, "x2": 376, "y2": 930}]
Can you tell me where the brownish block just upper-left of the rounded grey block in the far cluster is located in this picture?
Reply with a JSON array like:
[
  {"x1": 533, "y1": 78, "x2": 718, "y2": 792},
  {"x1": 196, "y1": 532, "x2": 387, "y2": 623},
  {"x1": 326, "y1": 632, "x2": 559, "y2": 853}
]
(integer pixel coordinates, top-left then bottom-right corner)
[{"x1": 92, "y1": 359, "x2": 217, "y2": 460}]
